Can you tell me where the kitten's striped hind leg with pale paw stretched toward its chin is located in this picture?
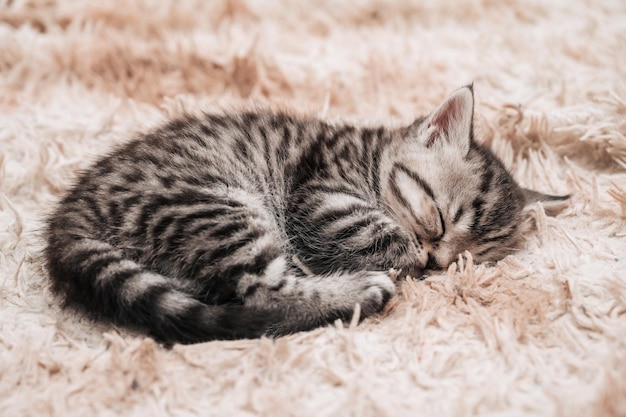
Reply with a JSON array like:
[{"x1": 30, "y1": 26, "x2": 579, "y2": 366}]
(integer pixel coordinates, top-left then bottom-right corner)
[{"x1": 153, "y1": 189, "x2": 395, "y2": 334}]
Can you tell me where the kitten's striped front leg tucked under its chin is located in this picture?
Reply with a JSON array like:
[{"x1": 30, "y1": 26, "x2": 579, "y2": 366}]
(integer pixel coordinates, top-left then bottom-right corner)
[{"x1": 290, "y1": 190, "x2": 427, "y2": 277}]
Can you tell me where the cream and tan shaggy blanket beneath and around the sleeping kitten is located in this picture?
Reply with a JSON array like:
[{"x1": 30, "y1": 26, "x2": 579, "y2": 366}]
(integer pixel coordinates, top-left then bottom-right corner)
[{"x1": 0, "y1": 0, "x2": 626, "y2": 416}]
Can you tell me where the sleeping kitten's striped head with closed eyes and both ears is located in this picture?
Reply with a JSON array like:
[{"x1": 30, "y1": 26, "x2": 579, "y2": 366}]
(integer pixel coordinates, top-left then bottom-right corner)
[{"x1": 383, "y1": 86, "x2": 567, "y2": 269}]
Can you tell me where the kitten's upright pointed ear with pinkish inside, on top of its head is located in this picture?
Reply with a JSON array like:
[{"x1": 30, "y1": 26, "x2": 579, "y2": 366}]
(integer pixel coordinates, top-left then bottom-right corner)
[{"x1": 425, "y1": 85, "x2": 474, "y2": 154}]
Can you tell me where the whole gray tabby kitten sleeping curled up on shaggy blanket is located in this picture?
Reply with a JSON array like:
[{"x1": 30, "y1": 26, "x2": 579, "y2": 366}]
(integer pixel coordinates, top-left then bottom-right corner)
[{"x1": 45, "y1": 86, "x2": 558, "y2": 343}]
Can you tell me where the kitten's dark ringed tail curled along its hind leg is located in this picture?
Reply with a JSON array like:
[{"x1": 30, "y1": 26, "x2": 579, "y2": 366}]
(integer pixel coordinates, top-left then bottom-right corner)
[{"x1": 45, "y1": 233, "x2": 280, "y2": 343}]
